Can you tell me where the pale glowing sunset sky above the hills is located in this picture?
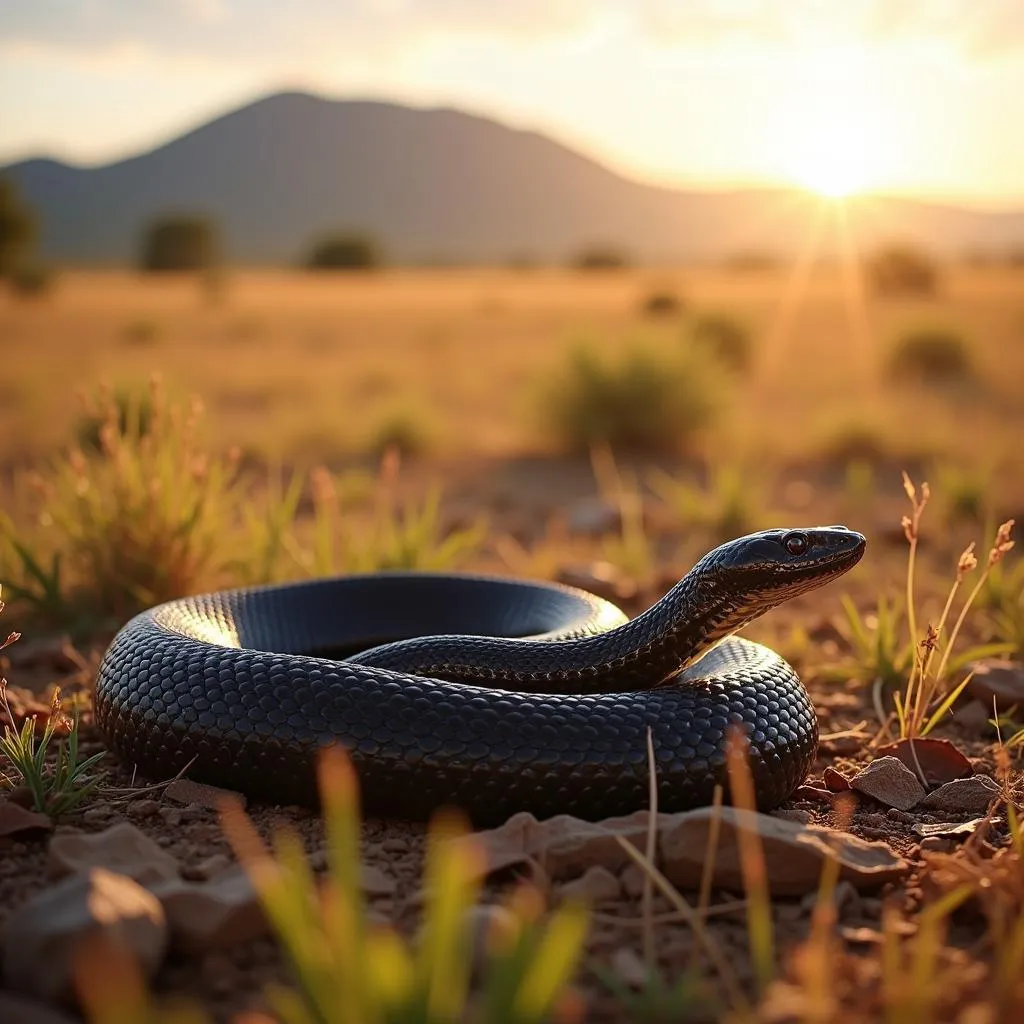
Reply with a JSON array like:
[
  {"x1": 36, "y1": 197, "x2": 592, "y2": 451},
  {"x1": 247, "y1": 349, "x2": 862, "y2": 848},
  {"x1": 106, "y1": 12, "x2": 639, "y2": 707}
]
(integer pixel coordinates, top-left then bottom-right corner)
[{"x1": 0, "y1": 0, "x2": 1024, "y2": 206}]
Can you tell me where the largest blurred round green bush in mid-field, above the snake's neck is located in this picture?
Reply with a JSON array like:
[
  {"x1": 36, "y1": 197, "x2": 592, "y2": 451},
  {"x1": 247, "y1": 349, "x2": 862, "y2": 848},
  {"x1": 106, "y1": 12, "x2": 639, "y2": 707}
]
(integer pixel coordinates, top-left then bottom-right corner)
[{"x1": 543, "y1": 346, "x2": 720, "y2": 452}]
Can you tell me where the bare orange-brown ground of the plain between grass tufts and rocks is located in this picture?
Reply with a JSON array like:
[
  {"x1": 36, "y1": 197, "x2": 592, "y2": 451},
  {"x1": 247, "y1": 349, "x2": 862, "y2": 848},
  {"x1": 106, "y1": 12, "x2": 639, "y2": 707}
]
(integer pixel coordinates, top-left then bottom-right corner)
[{"x1": 0, "y1": 269, "x2": 1024, "y2": 1021}]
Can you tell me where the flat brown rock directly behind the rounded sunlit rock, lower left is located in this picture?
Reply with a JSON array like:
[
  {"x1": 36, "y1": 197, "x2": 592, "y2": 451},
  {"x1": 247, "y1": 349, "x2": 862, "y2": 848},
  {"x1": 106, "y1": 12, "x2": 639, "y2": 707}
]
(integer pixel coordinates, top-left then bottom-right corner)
[{"x1": 48, "y1": 821, "x2": 178, "y2": 886}]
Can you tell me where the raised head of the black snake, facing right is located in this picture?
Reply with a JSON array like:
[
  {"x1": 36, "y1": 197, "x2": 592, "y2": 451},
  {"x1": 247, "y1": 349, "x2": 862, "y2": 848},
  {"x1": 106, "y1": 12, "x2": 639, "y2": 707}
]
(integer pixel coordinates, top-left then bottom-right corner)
[{"x1": 702, "y1": 526, "x2": 867, "y2": 613}]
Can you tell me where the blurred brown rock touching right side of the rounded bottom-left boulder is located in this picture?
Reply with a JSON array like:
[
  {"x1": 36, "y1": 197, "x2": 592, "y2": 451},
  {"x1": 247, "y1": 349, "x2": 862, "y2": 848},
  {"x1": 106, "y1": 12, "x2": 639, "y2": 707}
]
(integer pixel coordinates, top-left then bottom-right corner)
[{"x1": 153, "y1": 867, "x2": 267, "y2": 952}]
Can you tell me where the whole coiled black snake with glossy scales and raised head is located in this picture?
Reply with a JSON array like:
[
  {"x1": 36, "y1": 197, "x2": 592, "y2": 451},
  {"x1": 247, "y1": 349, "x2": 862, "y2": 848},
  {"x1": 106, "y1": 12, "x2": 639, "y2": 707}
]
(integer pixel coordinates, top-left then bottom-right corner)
[{"x1": 96, "y1": 527, "x2": 864, "y2": 823}]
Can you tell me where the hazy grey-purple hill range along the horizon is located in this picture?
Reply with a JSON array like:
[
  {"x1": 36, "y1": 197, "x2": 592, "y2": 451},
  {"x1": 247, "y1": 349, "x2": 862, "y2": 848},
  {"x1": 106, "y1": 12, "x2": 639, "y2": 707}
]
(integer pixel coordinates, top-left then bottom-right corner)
[{"x1": 0, "y1": 93, "x2": 1024, "y2": 263}]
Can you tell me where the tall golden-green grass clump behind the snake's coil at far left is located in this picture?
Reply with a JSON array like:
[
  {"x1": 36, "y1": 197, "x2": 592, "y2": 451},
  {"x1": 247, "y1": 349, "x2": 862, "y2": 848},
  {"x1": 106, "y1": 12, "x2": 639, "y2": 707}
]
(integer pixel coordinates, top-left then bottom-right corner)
[{"x1": 3, "y1": 381, "x2": 239, "y2": 627}]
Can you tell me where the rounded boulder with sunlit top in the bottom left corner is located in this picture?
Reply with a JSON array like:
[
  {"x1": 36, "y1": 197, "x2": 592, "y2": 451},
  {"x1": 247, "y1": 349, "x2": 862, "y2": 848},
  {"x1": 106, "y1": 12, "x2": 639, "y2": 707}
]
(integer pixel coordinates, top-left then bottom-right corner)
[{"x1": 3, "y1": 867, "x2": 167, "y2": 1002}]
